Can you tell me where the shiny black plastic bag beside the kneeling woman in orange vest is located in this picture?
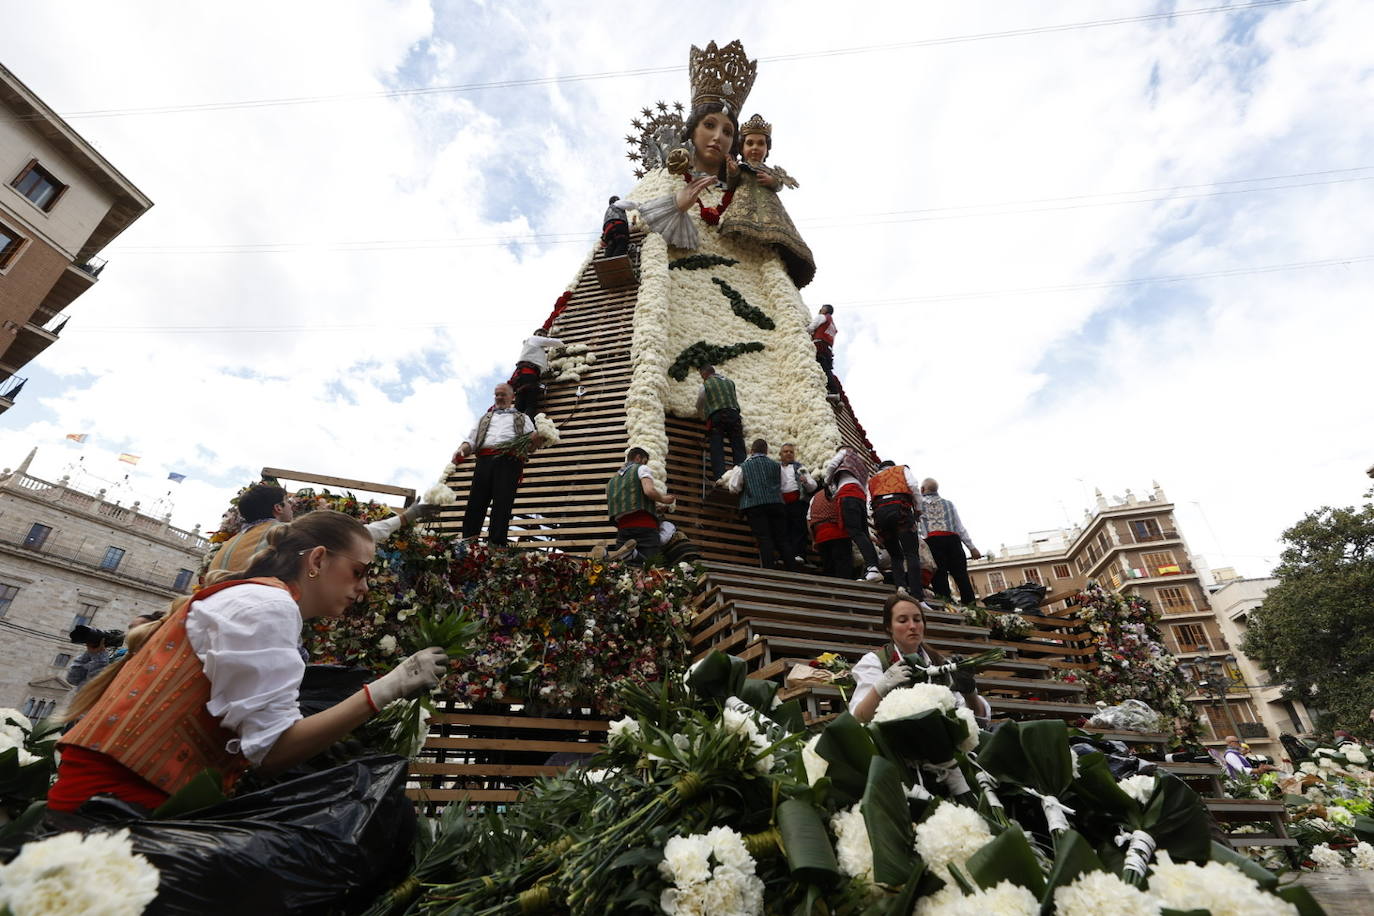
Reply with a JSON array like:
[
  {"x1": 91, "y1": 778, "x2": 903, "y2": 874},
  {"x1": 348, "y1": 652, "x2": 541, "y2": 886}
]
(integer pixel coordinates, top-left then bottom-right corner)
[{"x1": 14, "y1": 755, "x2": 416, "y2": 916}]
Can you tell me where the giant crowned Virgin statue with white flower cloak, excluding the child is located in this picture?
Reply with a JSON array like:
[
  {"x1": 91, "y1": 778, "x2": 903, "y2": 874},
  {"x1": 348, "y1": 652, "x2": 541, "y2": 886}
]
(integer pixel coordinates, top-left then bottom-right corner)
[{"x1": 621, "y1": 41, "x2": 840, "y2": 479}]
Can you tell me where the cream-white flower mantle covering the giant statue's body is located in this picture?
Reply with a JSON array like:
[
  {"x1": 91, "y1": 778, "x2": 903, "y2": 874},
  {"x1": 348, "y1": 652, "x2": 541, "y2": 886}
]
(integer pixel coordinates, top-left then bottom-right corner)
[{"x1": 625, "y1": 169, "x2": 840, "y2": 479}]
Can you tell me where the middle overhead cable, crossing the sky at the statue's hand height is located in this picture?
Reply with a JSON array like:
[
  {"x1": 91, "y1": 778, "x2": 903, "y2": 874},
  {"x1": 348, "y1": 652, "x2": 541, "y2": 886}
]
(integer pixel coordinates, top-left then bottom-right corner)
[{"x1": 112, "y1": 165, "x2": 1374, "y2": 255}]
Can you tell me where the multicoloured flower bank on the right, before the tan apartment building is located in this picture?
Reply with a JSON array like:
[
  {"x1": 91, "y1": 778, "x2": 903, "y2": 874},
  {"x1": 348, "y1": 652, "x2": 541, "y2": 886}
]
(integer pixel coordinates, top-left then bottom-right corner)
[{"x1": 1059, "y1": 582, "x2": 1198, "y2": 743}]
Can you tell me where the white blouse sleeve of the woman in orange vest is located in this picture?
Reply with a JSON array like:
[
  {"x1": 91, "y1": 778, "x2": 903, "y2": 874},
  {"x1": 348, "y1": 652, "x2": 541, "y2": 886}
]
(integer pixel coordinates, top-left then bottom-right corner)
[{"x1": 185, "y1": 584, "x2": 305, "y2": 765}]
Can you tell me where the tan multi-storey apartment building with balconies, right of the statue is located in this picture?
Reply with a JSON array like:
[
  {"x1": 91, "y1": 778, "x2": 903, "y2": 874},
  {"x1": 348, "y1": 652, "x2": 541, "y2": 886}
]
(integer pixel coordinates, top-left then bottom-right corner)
[{"x1": 969, "y1": 482, "x2": 1292, "y2": 755}]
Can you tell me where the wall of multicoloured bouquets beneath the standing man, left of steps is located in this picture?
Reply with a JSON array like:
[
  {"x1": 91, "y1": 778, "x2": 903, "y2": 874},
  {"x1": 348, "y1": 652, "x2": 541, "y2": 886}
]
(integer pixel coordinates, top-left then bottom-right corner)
[{"x1": 305, "y1": 541, "x2": 697, "y2": 711}]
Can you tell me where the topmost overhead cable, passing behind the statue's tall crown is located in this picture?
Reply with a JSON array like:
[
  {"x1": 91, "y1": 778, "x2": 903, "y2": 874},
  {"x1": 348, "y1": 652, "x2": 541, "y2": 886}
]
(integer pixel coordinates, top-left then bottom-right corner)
[{"x1": 2, "y1": 0, "x2": 1305, "y2": 122}]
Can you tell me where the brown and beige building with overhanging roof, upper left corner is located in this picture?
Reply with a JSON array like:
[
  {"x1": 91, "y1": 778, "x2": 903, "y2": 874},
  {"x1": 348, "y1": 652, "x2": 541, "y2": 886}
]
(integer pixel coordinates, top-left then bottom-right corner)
[{"x1": 0, "y1": 66, "x2": 153, "y2": 413}]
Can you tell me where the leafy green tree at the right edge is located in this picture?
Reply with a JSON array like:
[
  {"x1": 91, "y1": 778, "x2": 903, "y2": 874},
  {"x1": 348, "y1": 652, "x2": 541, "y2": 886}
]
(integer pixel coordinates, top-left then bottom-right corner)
[{"x1": 1243, "y1": 490, "x2": 1374, "y2": 737}]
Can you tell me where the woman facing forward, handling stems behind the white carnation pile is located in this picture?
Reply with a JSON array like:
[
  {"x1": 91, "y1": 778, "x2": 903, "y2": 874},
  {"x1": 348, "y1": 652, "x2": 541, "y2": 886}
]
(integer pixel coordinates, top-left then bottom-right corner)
[{"x1": 849, "y1": 593, "x2": 992, "y2": 726}]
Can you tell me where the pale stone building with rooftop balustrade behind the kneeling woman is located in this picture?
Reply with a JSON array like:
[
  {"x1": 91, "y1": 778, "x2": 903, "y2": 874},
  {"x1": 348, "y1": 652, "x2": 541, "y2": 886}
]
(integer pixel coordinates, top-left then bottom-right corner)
[{"x1": 0, "y1": 452, "x2": 209, "y2": 715}]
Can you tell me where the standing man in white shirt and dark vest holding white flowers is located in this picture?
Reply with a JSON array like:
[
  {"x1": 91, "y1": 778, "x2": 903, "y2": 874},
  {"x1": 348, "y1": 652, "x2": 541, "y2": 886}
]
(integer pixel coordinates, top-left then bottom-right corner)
[{"x1": 453, "y1": 382, "x2": 540, "y2": 547}]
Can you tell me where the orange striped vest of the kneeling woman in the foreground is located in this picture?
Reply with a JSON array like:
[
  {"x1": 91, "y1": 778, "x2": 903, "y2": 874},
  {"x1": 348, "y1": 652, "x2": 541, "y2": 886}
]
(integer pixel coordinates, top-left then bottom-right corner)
[{"x1": 58, "y1": 579, "x2": 286, "y2": 795}]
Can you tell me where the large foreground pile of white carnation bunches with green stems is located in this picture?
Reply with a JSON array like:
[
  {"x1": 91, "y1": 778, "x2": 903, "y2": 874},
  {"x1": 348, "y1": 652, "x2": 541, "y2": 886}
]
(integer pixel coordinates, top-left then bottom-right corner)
[{"x1": 368, "y1": 652, "x2": 1320, "y2": 916}]
